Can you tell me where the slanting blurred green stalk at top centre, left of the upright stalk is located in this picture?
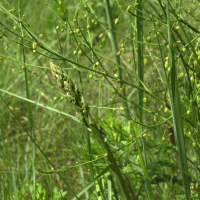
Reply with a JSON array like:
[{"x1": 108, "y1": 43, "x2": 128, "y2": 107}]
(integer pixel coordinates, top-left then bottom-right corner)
[{"x1": 105, "y1": 0, "x2": 130, "y2": 117}]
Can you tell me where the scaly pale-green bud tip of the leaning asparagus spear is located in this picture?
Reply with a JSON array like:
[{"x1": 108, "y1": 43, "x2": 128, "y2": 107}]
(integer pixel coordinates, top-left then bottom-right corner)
[{"x1": 50, "y1": 62, "x2": 89, "y2": 121}]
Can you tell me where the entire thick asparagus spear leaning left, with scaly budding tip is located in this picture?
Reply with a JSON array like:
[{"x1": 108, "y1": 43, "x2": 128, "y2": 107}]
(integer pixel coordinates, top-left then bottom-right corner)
[{"x1": 50, "y1": 62, "x2": 130, "y2": 200}]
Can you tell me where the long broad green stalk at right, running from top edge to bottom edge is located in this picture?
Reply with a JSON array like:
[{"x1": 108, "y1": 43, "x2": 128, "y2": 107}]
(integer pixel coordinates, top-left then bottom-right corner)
[{"x1": 166, "y1": 0, "x2": 190, "y2": 200}]
